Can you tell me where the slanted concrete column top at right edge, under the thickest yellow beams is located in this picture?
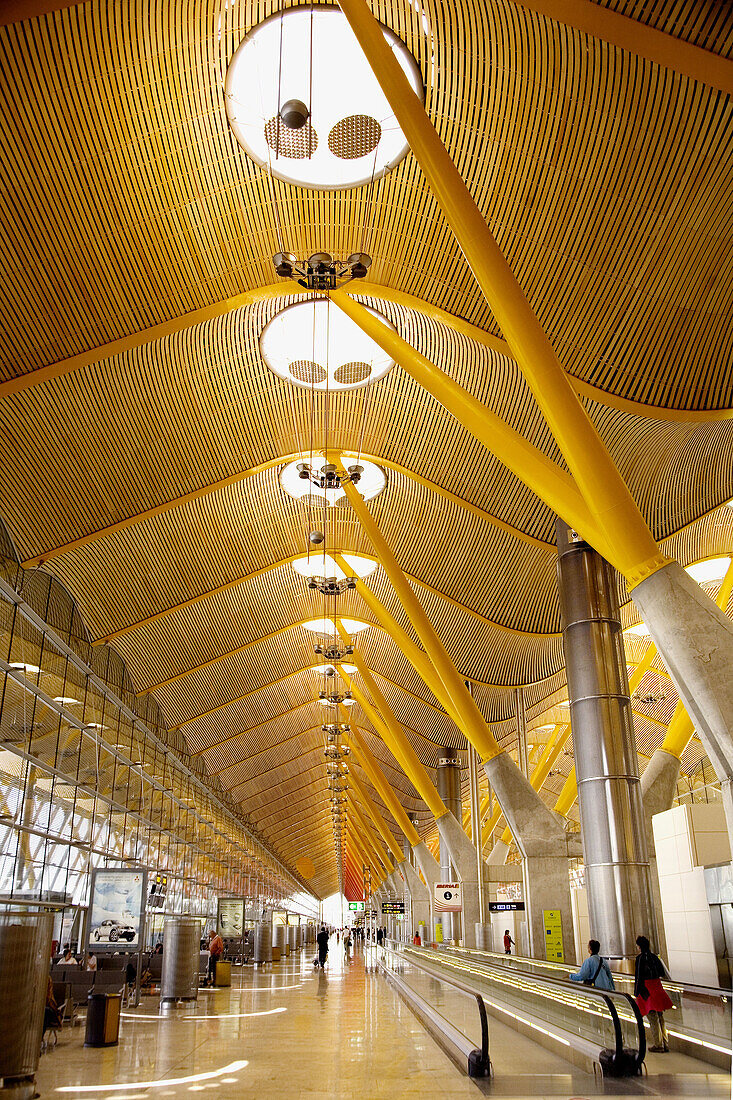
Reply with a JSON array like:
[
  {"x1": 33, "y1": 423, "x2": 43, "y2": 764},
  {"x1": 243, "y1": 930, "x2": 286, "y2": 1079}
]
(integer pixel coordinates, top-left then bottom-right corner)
[{"x1": 632, "y1": 562, "x2": 733, "y2": 842}]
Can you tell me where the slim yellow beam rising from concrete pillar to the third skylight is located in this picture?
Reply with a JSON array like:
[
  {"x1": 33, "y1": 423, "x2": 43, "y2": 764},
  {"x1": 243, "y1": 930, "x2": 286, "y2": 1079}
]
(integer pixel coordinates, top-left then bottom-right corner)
[{"x1": 342, "y1": 477, "x2": 502, "y2": 761}]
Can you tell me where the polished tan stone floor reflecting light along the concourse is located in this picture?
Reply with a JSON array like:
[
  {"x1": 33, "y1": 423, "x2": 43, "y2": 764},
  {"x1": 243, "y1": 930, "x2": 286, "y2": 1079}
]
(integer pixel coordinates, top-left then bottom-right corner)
[{"x1": 37, "y1": 941, "x2": 731, "y2": 1100}]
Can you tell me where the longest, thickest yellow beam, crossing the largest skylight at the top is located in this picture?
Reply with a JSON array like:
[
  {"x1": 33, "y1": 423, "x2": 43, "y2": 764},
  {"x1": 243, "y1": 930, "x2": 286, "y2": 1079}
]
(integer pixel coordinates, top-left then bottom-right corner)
[{"x1": 339, "y1": 0, "x2": 669, "y2": 589}]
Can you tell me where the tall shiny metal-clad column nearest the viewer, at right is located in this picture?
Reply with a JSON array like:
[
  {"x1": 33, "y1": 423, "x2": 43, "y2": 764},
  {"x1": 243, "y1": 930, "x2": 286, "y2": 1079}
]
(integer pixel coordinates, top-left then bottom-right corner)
[{"x1": 557, "y1": 519, "x2": 656, "y2": 959}]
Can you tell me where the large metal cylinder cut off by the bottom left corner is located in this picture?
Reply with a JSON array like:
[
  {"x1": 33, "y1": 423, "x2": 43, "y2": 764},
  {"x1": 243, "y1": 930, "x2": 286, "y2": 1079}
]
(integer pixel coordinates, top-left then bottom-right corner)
[{"x1": 0, "y1": 913, "x2": 53, "y2": 1100}]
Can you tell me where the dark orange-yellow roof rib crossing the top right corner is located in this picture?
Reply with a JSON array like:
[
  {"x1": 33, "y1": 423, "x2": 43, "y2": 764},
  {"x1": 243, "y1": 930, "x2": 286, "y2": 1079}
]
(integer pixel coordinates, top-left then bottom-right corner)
[{"x1": 511, "y1": 0, "x2": 733, "y2": 96}]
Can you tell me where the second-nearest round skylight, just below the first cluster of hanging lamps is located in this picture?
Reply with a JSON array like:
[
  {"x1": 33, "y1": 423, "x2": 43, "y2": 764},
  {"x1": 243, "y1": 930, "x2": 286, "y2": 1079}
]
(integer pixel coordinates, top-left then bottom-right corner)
[{"x1": 260, "y1": 298, "x2": 394, "y2": 393}]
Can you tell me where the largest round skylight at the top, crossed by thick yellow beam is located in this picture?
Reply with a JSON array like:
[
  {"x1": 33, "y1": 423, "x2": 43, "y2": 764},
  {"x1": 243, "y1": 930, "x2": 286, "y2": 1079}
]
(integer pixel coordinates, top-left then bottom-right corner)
[{"x1": 225, "y1": 7, "x2": 424, "y2": 190}]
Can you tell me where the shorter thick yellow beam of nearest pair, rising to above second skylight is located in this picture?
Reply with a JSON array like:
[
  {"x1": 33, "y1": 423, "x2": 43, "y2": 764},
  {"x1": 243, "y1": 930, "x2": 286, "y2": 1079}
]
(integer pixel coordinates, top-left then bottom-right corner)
[{"x1": 331, "y1": 290, "x2": 600, "y2": 546}]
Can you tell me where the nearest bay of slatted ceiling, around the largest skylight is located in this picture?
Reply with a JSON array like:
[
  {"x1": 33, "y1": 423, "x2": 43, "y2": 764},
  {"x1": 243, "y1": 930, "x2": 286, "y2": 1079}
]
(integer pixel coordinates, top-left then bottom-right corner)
[{"x1": 0, "y1": 0, "x2": 732, "y2": 407}]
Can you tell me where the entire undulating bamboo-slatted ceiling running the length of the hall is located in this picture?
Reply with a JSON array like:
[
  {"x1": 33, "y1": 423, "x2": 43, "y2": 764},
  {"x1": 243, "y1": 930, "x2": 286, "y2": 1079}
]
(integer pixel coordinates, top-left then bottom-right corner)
[{"x1": 0, "y1": 0, "x2": 733, "y2": 894}]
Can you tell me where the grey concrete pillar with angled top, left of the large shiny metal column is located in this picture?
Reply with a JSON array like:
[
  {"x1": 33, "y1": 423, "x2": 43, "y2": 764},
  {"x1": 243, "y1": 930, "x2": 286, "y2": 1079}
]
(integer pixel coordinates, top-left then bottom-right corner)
[{"x1": 483, "y1": 752, "x2": 575, "y2": 959}]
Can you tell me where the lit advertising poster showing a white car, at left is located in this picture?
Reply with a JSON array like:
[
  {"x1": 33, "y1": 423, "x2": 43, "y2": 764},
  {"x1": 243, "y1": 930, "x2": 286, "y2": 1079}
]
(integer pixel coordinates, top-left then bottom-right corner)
[{"x1": 88, "y1": 867, "x2": 147, "y2": 952}]
